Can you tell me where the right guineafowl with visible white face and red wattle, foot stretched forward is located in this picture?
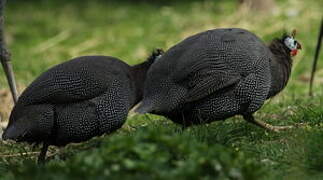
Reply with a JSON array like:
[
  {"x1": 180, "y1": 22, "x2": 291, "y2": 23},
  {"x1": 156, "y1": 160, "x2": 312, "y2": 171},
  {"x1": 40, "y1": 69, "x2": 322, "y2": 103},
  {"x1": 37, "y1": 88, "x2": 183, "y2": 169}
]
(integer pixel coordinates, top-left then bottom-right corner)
[{"x1": 136, "y1": 28, "x2": 301, "y2": 131}]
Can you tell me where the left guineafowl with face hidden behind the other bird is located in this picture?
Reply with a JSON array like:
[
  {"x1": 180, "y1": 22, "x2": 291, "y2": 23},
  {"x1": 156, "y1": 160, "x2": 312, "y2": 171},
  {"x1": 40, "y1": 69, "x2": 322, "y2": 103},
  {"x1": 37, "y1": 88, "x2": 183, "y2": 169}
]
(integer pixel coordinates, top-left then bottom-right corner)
[{"x1": 2, "y1": 50, "x2": 162, "y2": 162}]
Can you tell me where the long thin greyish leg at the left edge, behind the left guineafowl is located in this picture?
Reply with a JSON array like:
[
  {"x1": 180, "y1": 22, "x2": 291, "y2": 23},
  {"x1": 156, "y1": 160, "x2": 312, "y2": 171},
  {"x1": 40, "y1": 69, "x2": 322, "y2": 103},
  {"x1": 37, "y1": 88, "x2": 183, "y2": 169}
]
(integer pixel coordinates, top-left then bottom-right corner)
[{"x1": 0, "y1": 0, "x2": 18, "y2": 103}]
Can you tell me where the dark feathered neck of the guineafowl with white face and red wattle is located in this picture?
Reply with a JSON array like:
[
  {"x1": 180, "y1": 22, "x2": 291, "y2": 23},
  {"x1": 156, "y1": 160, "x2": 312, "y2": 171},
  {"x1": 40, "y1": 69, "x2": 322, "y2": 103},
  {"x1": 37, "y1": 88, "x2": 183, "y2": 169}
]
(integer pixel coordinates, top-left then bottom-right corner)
[{"x1": 267, "y1": 39, "x2": 292, "y2": 98}]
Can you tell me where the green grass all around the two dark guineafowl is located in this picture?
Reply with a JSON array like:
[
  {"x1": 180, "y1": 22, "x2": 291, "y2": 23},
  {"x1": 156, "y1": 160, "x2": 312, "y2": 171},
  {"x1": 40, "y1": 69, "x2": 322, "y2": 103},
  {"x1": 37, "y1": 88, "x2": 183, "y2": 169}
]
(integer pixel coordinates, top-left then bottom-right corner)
[{"x1": 0, "y1": 0, "x2": 323, "y2": 179}]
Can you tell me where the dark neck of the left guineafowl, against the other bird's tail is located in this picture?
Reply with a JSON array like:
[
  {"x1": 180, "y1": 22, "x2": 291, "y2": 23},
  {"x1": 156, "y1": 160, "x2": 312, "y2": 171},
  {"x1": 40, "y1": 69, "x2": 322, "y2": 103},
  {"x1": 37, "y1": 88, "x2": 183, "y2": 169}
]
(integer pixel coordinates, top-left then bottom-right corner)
[{"x1": 131, "y1": 60, "x2": 153, "y2": 105}]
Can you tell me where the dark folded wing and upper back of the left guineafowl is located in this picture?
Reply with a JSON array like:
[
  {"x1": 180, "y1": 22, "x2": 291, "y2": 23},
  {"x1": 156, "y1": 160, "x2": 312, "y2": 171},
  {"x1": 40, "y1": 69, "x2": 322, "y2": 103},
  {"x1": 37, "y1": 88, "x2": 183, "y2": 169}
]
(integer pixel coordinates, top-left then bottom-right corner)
[{"x1": 19, "y1": 56, "x2": 128, "y2": 104}]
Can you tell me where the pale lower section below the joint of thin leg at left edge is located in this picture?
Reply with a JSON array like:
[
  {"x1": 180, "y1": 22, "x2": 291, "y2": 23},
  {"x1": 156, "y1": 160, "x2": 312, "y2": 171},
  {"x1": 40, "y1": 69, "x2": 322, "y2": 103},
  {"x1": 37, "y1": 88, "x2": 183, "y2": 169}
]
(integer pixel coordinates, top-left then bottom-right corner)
[{"x1": 0, "y1": 51, "x2": 18, "y2": 103}]
